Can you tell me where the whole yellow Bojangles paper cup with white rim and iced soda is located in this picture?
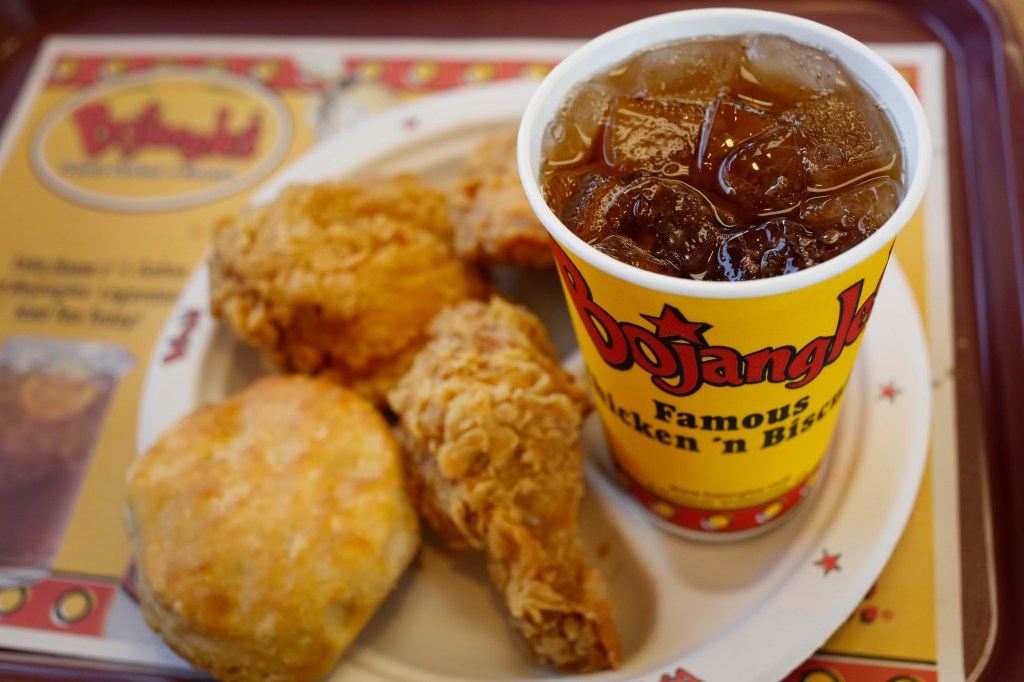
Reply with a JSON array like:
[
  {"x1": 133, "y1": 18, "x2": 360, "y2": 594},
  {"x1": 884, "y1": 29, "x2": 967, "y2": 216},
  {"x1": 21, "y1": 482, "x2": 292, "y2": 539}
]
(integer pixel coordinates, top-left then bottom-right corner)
[{"x1": 517, "y1": 9, "x2": 931, "y2": 540}]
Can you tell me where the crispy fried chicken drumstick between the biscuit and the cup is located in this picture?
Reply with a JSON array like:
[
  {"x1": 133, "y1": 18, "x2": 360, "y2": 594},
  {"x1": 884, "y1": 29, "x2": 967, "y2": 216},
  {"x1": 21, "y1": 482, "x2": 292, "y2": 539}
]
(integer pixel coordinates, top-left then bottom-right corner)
[{"x1": 388, "y1": 297, "x2": 618, "y2": 672}]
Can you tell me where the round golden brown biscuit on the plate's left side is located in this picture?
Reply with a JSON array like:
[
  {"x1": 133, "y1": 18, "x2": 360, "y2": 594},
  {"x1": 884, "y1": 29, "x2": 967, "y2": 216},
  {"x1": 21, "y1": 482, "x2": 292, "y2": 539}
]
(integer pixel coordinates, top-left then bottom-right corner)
[{"x1": 126, "y1": 376, "x2": 420, "y2": 682}]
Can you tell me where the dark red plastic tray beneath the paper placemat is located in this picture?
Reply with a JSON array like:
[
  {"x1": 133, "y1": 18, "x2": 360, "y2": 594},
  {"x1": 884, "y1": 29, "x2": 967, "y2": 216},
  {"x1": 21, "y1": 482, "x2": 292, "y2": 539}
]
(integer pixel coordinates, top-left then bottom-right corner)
[{"x1": 0, "y1": 0, "x2": 1024, "y2": 682}]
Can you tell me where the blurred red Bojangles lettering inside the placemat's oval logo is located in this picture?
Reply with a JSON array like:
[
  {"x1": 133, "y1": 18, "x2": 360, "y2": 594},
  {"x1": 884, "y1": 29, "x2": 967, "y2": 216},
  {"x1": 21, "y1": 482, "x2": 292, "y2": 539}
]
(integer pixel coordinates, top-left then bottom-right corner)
[{"x1": 74, "y1": 102, "x2": 260, "y2": 161}]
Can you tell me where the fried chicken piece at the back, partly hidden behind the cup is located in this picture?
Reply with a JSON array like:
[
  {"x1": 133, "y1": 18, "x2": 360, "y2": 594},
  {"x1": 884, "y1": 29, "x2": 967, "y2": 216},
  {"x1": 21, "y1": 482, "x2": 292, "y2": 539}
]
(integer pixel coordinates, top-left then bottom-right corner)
[{"x1": 452, "y1": 128, "x2": 554, "y2": 267}]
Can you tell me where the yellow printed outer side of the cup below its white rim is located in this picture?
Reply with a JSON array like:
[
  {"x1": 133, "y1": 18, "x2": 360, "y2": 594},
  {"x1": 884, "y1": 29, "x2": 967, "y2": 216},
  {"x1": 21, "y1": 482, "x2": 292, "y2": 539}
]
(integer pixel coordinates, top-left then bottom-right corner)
[{"x1": 554, "y1": 244, "x2": 891, "y2": 537}]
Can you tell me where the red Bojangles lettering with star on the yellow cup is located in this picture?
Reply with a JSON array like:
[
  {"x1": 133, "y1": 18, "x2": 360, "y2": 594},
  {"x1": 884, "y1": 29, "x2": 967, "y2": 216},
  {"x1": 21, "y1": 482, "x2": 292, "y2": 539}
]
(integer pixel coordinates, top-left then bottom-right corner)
[{"x1": 554, "y1": 245, "x2": 878, "y2": 395}]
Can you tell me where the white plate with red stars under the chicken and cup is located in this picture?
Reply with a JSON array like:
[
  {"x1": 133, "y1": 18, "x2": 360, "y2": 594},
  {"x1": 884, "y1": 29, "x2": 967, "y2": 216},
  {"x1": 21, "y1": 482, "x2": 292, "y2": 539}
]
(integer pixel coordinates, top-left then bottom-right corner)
[{"x1": 138, "y1": 82, "x2": 931, "y2": 682}]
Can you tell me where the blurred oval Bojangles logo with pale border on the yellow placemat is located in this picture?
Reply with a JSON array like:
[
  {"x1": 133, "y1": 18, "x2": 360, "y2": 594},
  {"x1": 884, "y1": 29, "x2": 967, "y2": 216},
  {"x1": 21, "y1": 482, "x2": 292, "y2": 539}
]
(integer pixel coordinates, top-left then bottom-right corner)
[{"x1": 32, "y1": 69, "x2": 292, "y2": 212}]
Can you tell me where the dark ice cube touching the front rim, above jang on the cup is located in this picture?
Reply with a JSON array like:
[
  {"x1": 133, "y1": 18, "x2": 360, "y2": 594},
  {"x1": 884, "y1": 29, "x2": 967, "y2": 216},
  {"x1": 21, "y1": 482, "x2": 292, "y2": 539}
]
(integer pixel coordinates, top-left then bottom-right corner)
[{"x1": 713, "y1": 218, "x2": 814, "y2": 282}]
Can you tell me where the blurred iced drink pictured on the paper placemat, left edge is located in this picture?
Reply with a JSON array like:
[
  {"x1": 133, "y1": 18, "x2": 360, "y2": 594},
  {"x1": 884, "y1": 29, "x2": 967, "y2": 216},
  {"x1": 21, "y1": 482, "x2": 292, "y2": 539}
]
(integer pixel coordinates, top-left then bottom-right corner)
[{"x1": 0, "y1": 337, "x2": 132, "y2": 587}]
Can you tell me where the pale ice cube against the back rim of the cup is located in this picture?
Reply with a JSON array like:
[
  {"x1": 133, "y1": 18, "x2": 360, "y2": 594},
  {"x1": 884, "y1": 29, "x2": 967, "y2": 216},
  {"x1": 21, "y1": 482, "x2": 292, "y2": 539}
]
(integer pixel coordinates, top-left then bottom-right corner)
[{"x1": 741, "y1": 34, "x2": 841, "y2": 99}]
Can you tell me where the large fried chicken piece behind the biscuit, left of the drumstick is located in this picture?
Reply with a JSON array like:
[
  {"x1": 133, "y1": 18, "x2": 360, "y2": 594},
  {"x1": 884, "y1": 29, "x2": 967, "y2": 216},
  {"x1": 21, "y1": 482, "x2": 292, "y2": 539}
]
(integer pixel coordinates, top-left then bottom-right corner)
[{"x1": 210, "y1": 175, "x2": 485, "y2": 406}]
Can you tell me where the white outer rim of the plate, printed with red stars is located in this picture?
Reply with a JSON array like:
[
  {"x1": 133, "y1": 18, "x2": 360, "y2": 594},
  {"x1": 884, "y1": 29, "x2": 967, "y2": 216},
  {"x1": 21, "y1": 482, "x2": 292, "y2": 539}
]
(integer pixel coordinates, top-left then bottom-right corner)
[{"x1": 136, "y1": 81, "x2": 931, "y2": 682}]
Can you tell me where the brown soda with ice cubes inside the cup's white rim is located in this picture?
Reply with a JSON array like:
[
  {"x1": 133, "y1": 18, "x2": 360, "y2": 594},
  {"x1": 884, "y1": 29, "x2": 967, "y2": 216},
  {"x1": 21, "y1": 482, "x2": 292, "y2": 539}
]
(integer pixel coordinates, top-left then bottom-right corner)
[{"x1": 541, "y1": 34, "x2": 903, "y2": 281}]
